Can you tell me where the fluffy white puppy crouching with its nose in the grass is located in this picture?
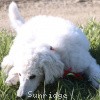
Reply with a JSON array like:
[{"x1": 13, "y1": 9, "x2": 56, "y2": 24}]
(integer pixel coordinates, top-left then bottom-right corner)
[{"x1": 1, "y1": 2, "x2": 100, "y2": 98}]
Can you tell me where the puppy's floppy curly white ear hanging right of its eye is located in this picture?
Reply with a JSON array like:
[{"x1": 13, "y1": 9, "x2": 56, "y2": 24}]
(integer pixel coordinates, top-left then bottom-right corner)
[{"x1": 42, "y1": 55, "x2": 64, "y2": 84}]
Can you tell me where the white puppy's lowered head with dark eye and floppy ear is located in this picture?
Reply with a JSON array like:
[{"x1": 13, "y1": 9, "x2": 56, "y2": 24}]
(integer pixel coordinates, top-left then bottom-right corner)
[{"x1": 17, "y1": 46, "x2": 64, "y2": 97}]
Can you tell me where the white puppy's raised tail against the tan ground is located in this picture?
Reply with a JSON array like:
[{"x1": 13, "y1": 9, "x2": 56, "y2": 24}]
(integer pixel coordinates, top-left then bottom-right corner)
[{"x1": 9, "y1": 2, "x2": 25, "y2": 31}]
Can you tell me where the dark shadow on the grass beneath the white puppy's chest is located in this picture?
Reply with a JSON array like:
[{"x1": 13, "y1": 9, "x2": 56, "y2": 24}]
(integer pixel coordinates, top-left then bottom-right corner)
[{"x1": 33, "y1": 76, "x2": 97, "y2": 100}]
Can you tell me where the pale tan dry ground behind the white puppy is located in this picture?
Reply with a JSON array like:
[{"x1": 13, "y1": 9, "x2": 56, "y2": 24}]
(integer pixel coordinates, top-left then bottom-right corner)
[{"x1": 0, "y1": 0, "x2": 100, "y2": 30}]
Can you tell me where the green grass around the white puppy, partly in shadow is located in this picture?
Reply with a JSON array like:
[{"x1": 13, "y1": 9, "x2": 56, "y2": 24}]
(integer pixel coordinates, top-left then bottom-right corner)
[{"x1": 0, "y1": 19, "x2": 100, "y2": 100}]
